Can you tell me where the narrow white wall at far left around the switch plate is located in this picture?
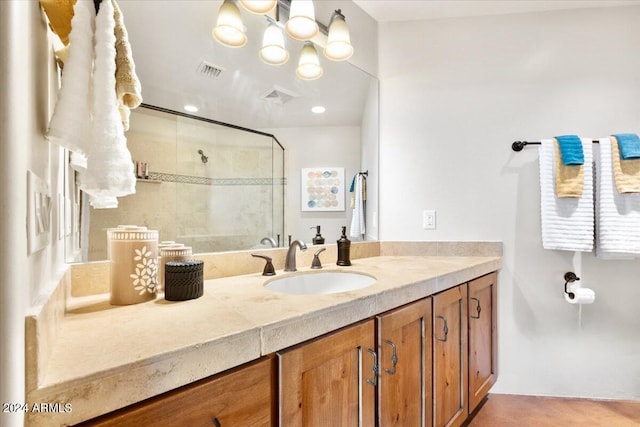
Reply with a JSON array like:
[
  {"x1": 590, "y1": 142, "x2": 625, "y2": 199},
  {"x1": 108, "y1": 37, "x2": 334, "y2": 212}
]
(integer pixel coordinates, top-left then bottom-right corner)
[{"x1": 0, "y1": 0, "x2": 66, "y2": 426}]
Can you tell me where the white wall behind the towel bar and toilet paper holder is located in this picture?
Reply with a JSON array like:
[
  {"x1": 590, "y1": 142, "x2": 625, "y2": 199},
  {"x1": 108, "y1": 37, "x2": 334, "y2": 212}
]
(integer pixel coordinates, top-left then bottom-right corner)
[{"x1": 379, "y1": 7, "x2": 640, "y2": 399}]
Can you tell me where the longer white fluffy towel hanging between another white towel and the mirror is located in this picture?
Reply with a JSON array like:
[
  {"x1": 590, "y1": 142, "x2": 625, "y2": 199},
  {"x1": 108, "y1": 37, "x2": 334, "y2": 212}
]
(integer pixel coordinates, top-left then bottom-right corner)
[{"x1": 80, "y1": 1, "x2": 136, "y2": 201}]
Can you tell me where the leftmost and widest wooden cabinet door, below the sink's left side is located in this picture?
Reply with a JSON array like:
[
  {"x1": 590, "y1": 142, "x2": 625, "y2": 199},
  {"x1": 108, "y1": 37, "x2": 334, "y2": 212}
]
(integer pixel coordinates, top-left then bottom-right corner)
[{"x1": 278, "y1": 320, "x2": 377, "y2": 427}]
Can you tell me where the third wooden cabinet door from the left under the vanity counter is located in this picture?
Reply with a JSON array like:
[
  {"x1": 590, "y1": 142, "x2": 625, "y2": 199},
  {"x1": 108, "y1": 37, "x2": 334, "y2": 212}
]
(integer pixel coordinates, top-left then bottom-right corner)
[{"x1": 433, "y1": 285, "x2": 469, "y2": 427}]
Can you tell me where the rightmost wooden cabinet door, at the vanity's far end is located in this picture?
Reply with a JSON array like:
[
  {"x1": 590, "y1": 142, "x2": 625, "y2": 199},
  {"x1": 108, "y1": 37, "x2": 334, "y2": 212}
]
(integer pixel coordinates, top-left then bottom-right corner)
[{"x1": 469, "y1": 273, "x2": 498, "y2": 413}]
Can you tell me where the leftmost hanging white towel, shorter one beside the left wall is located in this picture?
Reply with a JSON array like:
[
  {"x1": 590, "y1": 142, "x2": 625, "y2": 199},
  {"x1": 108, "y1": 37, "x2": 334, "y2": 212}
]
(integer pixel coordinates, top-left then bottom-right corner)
[{"x1": 47, "y1": 0, "x2": 96, "y2": 154}]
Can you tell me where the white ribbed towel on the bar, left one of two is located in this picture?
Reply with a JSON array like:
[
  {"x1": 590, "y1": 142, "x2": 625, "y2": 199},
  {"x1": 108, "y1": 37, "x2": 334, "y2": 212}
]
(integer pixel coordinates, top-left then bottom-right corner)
[{"x1": 539, "y1": 138, "x2": 594, "y2": 252}]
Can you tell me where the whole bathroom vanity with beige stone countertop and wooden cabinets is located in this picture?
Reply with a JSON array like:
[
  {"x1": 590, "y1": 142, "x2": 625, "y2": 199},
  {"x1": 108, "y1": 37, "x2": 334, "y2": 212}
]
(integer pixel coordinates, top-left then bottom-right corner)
[{"x1": 27, "y1": 242, "x2": 501, "y2": 426}]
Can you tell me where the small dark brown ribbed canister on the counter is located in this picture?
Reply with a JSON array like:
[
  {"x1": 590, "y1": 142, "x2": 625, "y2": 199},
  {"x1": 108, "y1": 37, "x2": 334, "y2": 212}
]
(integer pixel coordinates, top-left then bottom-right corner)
[{"x1": 164, "y1": 260, "x2": 204, "y2": 301}]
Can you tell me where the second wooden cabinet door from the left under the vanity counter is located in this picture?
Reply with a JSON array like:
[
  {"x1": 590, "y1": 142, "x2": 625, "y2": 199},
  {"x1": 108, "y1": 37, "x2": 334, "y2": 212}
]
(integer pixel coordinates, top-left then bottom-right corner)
[{"x1": 377, "y1": 298, "x2": 433, "y2": 427}]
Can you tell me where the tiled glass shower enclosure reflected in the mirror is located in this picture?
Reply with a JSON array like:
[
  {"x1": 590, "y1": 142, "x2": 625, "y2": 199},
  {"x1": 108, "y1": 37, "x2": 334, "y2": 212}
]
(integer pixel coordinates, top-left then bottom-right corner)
[{"x1": 83, "y1": 105, "x2": 286, "y2": 261}]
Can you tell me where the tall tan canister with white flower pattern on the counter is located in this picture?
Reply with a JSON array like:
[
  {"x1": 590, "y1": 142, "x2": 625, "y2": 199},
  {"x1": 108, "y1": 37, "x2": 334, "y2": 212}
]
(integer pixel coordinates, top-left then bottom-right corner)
[{"x1": 107, "y1": 226, "x2": 158, "y2": 305}]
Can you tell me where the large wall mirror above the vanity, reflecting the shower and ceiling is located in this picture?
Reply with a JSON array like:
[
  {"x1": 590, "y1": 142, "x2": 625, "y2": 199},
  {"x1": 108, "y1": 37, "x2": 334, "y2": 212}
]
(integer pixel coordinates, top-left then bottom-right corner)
[{"x1": 74, "y1": 0, "x2": 378, "y2": 261}]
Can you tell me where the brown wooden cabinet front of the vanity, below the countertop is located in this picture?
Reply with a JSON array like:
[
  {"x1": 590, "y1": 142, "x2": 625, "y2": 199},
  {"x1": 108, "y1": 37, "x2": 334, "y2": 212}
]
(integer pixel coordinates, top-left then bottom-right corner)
[{"x1": 76, "y1": 272, "x2": 497, "y2": 427}]
